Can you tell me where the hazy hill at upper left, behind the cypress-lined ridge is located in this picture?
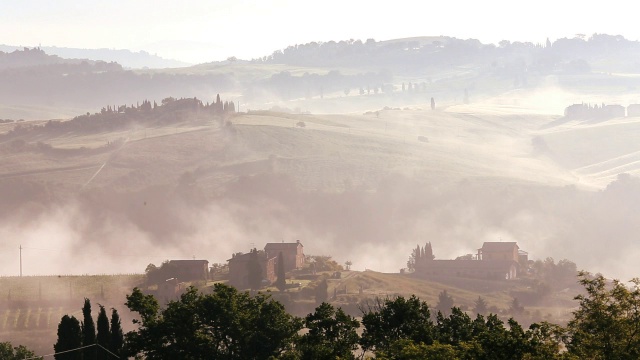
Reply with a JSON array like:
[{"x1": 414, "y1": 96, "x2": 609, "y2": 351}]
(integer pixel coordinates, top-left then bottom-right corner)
[{"x1": 0, "y1": 48, "x2": 230, "y2": 116}]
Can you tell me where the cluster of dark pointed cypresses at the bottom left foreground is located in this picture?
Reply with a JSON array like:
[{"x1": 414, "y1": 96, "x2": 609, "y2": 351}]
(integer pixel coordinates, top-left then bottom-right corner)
[{"x1": 53, "y1": 298, "x2": 127, "y2": 360}]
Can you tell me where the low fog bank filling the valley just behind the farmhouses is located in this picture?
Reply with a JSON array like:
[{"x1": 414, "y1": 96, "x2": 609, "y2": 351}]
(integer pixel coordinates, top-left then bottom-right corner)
[{"x1": 0, "y1": 174, "x2": 640, "y2": 280}]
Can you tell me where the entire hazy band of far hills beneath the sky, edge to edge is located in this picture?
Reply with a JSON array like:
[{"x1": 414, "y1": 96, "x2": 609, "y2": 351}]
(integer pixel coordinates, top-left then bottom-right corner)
[{"x1": 6, "y1": 34, "x2": 640, "y2": 120}]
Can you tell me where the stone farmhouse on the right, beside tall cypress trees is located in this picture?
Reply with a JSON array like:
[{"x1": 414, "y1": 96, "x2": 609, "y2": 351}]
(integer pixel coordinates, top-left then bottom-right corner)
[{"x1": 415, "y1": 242, "x2": 528, "y2": 280}]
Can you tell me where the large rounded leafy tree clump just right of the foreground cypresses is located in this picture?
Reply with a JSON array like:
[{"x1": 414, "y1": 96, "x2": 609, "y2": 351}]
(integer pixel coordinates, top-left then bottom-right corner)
[{"x1": 125, "y1": 284, "x2": 302, "y2": 360}]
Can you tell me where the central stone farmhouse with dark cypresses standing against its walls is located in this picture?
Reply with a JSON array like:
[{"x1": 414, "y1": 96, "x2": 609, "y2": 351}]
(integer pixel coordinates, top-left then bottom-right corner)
[{"x1": 227, "y1": 240, "x2": 304, "y2": 289}]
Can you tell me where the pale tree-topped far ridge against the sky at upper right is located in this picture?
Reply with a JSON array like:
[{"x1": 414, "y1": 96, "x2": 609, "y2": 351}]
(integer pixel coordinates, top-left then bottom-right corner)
[{"x1": 254, "y1": 34, "x2": 640, "y2": 76}]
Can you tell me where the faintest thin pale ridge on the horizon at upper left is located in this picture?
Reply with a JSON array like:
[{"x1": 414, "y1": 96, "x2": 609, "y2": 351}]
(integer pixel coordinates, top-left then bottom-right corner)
[{"x1": 0, "y1": 45, "x2": 191, "y2": 69}]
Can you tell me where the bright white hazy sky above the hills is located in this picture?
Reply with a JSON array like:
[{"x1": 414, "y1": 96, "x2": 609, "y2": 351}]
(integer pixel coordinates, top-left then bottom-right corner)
[{"x1": 0, "y1": 0, "x2": 640, "y2": 62}]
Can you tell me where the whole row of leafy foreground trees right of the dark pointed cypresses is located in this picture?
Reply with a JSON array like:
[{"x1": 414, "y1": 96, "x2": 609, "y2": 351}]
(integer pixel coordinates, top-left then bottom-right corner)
[{"x1": 94, "y1": 273, "x2": 640, "y2": 360}]
